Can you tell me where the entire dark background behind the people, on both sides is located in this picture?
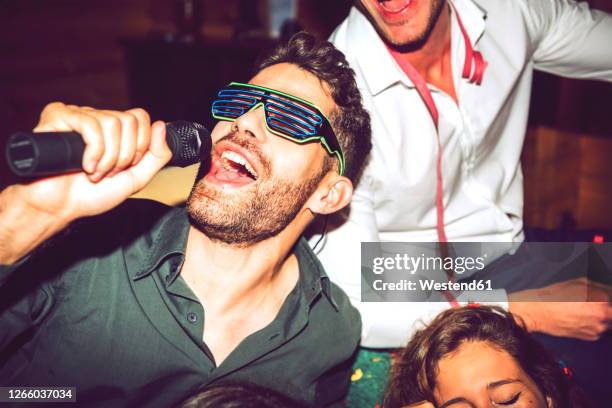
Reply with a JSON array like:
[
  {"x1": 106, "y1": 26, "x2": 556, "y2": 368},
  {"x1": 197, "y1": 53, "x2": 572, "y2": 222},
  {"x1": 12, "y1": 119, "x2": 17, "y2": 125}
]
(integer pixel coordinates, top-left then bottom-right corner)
[{"x1": 0, "y1": 0, "x2": 612, "y2": 230}]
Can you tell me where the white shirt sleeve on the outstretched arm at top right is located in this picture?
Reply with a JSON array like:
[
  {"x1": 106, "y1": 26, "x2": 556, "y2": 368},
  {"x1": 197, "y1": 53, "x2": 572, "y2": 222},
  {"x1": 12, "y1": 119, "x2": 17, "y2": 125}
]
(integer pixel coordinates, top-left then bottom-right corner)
[{"x1": 524, "y1": 0, "x2": 612, "y2": 81}]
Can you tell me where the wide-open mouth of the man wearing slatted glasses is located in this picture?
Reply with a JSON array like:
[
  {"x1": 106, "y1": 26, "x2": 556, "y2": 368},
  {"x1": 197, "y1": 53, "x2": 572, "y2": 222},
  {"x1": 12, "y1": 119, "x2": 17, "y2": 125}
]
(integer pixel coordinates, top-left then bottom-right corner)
[{"x1": 206, "y1": 147, "x2": 259, "y2": 189}]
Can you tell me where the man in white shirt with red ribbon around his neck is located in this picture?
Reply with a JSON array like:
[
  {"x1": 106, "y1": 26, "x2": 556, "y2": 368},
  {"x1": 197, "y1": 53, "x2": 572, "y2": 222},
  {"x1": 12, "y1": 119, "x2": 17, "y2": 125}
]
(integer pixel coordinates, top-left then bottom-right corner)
[{"x1": 319, "y1": 0, "x2": 612, "y2": 348}]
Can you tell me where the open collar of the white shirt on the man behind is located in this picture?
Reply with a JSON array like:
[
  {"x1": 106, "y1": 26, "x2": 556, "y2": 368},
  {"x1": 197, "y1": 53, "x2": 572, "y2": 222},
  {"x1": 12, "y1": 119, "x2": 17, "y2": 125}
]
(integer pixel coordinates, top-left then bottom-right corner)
[{"x1": 348, "y1": 0, "x2": 486, "y2": 96}]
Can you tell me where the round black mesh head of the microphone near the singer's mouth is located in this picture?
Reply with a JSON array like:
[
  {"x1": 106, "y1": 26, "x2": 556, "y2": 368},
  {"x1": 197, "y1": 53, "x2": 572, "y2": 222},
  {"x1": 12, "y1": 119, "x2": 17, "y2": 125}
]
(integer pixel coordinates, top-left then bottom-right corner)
[{"x1": 166, "y1": 120, "x2": 211, "y2": 167}]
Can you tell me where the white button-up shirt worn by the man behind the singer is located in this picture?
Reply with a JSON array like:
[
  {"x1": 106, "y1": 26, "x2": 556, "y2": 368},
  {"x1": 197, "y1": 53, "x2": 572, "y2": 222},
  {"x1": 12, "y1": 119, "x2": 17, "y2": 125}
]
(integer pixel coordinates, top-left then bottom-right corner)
[{"x1": 319, "y1": 0, "x2": 612, "y2": 347}]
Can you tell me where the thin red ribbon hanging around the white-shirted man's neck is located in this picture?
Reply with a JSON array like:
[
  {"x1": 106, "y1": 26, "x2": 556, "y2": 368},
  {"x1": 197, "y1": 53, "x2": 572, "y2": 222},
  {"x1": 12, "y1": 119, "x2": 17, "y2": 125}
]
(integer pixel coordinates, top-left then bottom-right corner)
[{"x1": 387, "y1": 0, "x2": 487, "y2": 307}]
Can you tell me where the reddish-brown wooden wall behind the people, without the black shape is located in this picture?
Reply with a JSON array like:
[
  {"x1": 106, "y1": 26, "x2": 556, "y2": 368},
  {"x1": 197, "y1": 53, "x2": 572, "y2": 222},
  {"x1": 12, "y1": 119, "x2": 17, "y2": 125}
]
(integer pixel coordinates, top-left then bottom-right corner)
[{"x1": 0, "y1": 0, "x2": 612, "y2": 233}]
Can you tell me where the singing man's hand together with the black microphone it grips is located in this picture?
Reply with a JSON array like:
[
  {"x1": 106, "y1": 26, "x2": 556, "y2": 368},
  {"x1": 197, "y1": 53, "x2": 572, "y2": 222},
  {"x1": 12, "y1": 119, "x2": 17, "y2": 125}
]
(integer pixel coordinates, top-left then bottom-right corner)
[{"x1": 6, "y1": 103, "x2": 210, "y2": 228}]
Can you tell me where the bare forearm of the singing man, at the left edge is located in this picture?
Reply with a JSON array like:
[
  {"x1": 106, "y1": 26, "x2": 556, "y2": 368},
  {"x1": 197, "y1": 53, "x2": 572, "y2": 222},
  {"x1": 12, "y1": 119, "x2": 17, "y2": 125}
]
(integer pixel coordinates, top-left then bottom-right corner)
[{"x1": 0, "y1": 186, "x2": 68, "y2": 265}]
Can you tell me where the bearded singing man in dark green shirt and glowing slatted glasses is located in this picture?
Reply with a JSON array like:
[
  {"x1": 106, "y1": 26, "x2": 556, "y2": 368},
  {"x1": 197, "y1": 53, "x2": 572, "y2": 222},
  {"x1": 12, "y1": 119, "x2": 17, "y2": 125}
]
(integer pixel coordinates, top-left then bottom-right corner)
[{"x1": 0, "y1": 34, "x2": 371, "y2": 406}]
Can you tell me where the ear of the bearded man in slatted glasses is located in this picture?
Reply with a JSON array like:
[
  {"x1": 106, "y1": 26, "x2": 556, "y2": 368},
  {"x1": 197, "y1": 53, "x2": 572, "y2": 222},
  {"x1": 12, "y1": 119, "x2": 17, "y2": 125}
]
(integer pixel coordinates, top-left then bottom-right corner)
[{"x1": 306, "y1": 172, "x2": 353, "y2": 215}]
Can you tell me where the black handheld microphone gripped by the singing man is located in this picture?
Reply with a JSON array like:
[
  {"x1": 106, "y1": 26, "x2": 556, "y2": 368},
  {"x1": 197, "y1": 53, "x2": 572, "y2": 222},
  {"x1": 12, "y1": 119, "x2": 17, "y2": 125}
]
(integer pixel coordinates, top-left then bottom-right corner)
[{"x1": 5, "y1": 120, "x2": 212, "y2": 177}]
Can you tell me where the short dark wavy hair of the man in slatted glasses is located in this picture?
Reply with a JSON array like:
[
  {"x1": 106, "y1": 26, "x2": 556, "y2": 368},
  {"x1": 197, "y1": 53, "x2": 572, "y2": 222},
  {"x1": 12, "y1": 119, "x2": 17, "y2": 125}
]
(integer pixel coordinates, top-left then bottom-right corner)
[{"x1": 257, "y1": 32, "x2": 372, "y2": 182}]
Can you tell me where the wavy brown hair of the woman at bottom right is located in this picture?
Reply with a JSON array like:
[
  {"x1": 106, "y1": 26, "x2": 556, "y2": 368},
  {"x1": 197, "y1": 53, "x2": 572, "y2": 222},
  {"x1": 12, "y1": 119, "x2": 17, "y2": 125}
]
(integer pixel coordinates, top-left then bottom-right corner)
[{"x1": 384, "y1": 306, "x2": 586, "y2": 408}]
